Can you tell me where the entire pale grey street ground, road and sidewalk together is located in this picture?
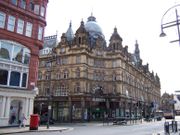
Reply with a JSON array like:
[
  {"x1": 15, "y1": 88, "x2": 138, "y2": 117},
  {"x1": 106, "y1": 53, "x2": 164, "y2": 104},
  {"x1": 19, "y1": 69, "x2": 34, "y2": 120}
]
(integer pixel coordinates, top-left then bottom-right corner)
[{"x1": 0, "y1": 117, "x2": 180, "y2": 135}]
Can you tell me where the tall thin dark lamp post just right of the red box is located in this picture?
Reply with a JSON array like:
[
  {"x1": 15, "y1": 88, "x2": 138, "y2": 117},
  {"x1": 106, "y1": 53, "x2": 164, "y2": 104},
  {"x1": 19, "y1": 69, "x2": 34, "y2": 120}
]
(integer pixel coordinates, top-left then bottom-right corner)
[{"x1": 47, "y1": 48, "x2": 56, "y2": 129}]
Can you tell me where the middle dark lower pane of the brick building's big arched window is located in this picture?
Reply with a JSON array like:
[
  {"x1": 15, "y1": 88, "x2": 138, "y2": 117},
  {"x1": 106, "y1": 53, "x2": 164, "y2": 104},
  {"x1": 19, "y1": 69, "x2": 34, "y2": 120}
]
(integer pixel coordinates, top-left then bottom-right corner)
[{"x1": 10, "y1": 71, "x2": 20, "y2": 86}]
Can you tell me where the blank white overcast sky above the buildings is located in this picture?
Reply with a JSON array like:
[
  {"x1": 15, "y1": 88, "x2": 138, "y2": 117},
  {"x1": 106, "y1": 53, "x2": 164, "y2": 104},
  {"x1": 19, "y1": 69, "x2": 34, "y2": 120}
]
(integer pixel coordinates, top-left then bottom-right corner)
[{"x1": 45, "y1": 0, "x2": 180, "y2": 93}]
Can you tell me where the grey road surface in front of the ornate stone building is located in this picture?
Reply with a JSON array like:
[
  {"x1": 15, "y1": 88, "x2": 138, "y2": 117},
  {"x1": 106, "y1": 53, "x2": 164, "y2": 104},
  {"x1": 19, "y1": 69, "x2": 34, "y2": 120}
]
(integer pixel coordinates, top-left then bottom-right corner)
[{"x1": 11, "y1": 121, "x2": 164, "y2": 135}]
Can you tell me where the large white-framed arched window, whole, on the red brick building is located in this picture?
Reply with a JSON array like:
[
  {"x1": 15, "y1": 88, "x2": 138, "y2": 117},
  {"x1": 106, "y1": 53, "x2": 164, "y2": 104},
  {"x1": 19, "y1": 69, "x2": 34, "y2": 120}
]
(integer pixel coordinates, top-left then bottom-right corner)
[{"x1": 0, "y1": 40, "x2": 30, "y2": 88}]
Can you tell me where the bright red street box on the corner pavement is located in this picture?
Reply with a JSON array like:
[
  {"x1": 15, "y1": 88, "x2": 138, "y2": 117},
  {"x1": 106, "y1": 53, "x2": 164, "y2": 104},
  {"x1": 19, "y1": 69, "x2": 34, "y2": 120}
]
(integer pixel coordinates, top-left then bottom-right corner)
[{"x1": 29, "y1": 114, "x2": 39, "y2": 130}]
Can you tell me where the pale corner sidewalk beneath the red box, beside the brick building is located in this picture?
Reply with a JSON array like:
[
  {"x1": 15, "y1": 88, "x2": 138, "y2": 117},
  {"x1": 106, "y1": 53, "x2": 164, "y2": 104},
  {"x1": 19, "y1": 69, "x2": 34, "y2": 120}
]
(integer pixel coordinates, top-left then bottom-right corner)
[{"x1": 0, "y1": 126, "x2": 69, "y2": 135}]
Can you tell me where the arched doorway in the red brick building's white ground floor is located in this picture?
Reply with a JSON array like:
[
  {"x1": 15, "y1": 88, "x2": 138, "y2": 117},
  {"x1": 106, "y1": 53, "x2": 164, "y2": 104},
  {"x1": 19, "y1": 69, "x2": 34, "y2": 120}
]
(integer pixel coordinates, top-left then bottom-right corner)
[{"x1": 9, "y1": 100, "x2": 22, "y2": 125}]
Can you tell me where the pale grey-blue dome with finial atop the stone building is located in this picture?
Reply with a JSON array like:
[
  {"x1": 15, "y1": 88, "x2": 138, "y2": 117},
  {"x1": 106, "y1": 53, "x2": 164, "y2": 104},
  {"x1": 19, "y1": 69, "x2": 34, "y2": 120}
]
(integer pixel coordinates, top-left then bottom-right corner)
[{"x1": 85, "y1": 14, "x2": 104, "y2": 38}]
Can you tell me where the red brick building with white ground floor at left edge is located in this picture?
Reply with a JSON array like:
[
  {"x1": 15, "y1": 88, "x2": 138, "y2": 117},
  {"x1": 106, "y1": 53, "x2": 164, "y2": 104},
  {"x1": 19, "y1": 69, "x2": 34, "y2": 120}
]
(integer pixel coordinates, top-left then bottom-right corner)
[{"x1": 0, "y1": 0, "x2": 48, "y2": 126}]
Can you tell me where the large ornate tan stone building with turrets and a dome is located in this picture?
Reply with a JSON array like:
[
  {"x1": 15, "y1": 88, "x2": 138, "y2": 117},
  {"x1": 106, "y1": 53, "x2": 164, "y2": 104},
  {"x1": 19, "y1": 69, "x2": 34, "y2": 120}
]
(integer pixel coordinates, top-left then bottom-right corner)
[{"x1": 35, "y1": 15, "x2": 160, "y2": 122}]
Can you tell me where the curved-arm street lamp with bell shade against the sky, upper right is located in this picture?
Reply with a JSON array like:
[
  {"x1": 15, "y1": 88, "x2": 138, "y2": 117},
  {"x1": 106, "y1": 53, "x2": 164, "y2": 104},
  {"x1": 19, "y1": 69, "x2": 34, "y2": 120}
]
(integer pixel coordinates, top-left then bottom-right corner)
[{"x1": 159, "y1": 4, "x2": 180, "y2": 45}]
